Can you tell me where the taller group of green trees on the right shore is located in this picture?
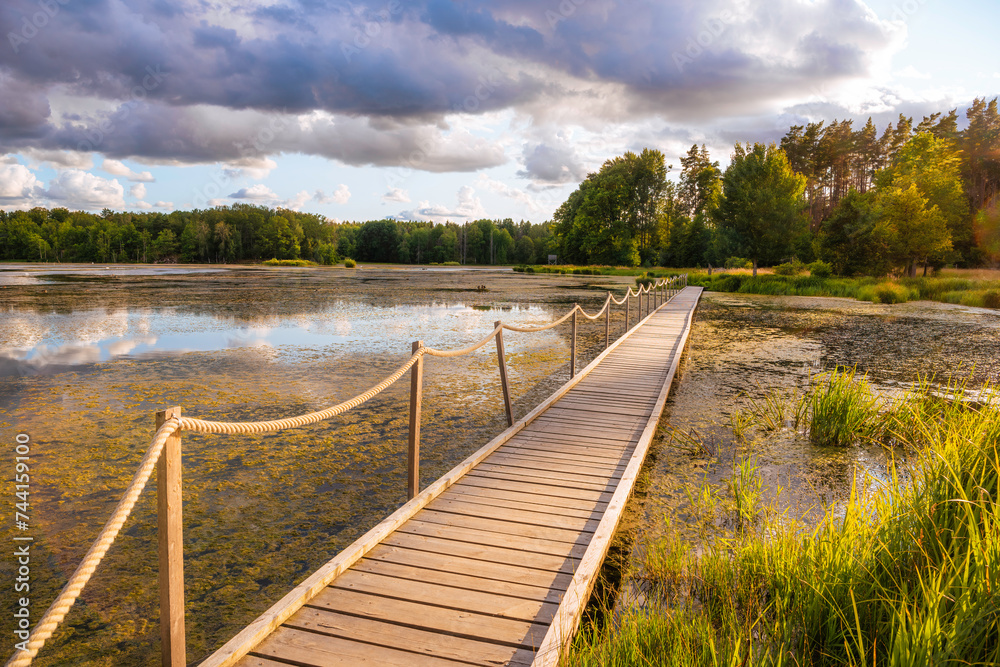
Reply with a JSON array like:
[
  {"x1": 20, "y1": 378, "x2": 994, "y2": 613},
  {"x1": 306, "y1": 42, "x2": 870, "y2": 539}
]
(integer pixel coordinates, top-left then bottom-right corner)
[{"x1": 553, "y1": 99, "x2": 1000, "y2": 275}]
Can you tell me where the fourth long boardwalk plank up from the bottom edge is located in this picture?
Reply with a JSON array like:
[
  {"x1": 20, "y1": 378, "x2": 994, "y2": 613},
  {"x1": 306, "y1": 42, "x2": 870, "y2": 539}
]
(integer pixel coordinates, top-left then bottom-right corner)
[{"x1": 330, "y1": 569, "x2": 557, "y2": 623}]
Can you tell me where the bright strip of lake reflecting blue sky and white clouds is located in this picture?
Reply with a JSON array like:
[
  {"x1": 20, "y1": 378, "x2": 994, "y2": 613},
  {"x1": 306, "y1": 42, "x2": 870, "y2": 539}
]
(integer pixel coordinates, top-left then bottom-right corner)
[{"x1": 0, "y1": 301, "x2": 572, "y2": 375}]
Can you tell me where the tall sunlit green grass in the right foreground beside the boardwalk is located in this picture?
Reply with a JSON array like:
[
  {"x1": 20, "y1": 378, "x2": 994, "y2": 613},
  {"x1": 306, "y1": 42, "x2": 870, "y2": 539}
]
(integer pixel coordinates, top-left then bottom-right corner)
[{"x1": 563, "y1": 373, "x2": 1000, "y2": 666}]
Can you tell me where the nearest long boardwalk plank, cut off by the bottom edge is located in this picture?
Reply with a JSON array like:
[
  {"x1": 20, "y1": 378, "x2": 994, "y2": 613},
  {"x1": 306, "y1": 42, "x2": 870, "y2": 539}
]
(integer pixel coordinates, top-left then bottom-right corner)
[{"x1": 254, "y1": 628, "x2": 468, "y2": 667}]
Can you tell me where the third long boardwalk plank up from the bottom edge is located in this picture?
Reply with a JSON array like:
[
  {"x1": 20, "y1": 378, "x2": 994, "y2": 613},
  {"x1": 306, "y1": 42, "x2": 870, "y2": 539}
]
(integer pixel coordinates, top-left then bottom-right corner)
[{"x1": 309, "y1": 588, "x2": 548, "y2": 649}]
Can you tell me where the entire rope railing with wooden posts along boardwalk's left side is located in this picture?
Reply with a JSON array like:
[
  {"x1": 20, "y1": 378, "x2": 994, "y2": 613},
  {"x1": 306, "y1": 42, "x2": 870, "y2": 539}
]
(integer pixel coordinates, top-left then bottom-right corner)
[{"x1": 6, "y1": 274, "x2": 687, "y2": 667}]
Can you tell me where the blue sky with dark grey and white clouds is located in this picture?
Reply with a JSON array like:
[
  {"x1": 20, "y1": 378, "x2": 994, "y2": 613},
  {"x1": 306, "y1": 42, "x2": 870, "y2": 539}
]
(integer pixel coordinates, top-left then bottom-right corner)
[{"x1": 0, "y1": 0, "x2": 1000, "y2": 223}]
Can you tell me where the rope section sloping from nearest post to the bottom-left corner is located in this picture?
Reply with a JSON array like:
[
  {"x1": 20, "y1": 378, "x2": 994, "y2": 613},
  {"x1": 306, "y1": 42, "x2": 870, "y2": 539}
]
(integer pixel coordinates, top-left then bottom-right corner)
[{"x1": 7, "y1": 419, "x2": 180, "y2": 667}]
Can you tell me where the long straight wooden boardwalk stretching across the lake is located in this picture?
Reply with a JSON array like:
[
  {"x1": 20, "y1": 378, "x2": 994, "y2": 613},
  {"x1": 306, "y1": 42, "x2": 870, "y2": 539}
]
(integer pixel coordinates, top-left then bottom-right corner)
[{"x1": 203, "y1": 287, "x2": 701, "y2": 667}]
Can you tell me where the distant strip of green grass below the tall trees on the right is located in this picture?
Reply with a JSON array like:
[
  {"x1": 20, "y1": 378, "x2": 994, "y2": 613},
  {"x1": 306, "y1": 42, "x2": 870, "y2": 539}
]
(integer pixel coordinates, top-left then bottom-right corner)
[{"x1": 688, "y1": 273, "x2": 1000, "y2": 308}]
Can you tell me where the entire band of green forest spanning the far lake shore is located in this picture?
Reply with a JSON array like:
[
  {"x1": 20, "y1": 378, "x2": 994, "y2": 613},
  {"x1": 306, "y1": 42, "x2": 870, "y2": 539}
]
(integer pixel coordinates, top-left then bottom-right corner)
[{"x1": 0, "y1": 99, "x2": 1000, "y2": 275}]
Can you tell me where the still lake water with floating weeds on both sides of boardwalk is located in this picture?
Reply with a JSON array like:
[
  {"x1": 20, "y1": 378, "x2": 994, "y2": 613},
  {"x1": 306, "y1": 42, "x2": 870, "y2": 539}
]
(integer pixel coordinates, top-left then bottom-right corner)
[{"x1": 0, "y1": 265, "x2": 1000, "y2": 665}]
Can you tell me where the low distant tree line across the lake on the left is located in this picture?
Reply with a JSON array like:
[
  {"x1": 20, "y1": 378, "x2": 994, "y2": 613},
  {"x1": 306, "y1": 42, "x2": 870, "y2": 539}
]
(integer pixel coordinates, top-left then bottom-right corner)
[{"x1": 0, "y1": 204, "x2": 556, "y2": 264}]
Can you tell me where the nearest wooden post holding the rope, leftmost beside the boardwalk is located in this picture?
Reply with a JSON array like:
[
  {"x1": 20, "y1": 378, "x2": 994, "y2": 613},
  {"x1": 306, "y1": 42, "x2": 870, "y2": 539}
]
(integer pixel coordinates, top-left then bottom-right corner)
[{"x1": 156, "y1": 407, "x2": 187, "y2": 667}]
